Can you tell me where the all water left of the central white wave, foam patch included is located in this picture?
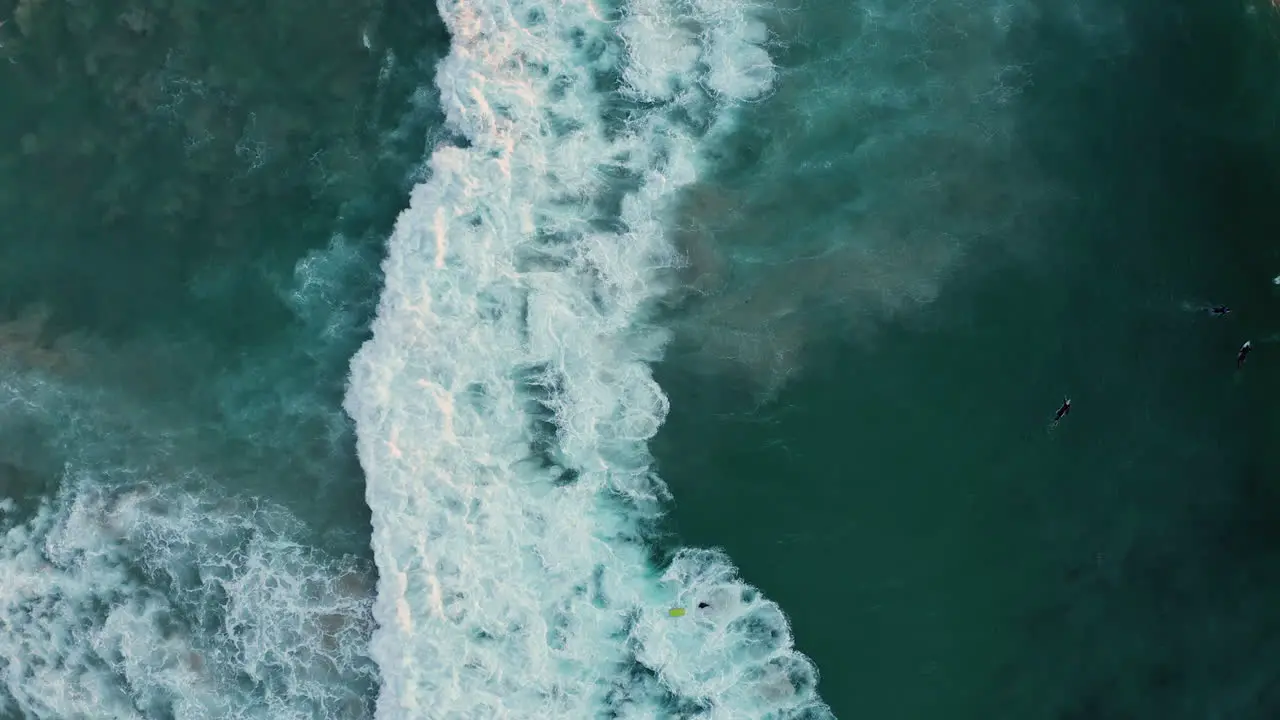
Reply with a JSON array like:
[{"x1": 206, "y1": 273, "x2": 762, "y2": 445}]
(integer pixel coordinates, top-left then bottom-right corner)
[{"x1": 0, "y1": 3, "x2": 447, "y2": 719}]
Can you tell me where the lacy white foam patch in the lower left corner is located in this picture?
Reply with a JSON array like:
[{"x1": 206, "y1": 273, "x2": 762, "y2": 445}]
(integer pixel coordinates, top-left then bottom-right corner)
[{"x1": 0, "y1": 473, "x2": 374, "y2": 720}]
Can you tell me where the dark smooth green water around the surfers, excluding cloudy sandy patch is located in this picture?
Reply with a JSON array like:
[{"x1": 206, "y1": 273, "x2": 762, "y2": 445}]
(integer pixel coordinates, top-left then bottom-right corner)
[{"x1": 654, "y1": 0, "x2": 1280, "y2": 720}]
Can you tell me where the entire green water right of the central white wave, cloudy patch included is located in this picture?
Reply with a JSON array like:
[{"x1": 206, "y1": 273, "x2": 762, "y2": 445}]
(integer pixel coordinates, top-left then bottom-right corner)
[{"x1": 654, "y1": 3, "x2": 1280, "y2": 720}]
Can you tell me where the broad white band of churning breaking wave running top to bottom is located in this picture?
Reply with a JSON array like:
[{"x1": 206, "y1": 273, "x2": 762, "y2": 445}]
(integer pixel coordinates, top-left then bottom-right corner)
[{"x1": 346, "y1": 0, "x2": 831, "y2": 719}]
